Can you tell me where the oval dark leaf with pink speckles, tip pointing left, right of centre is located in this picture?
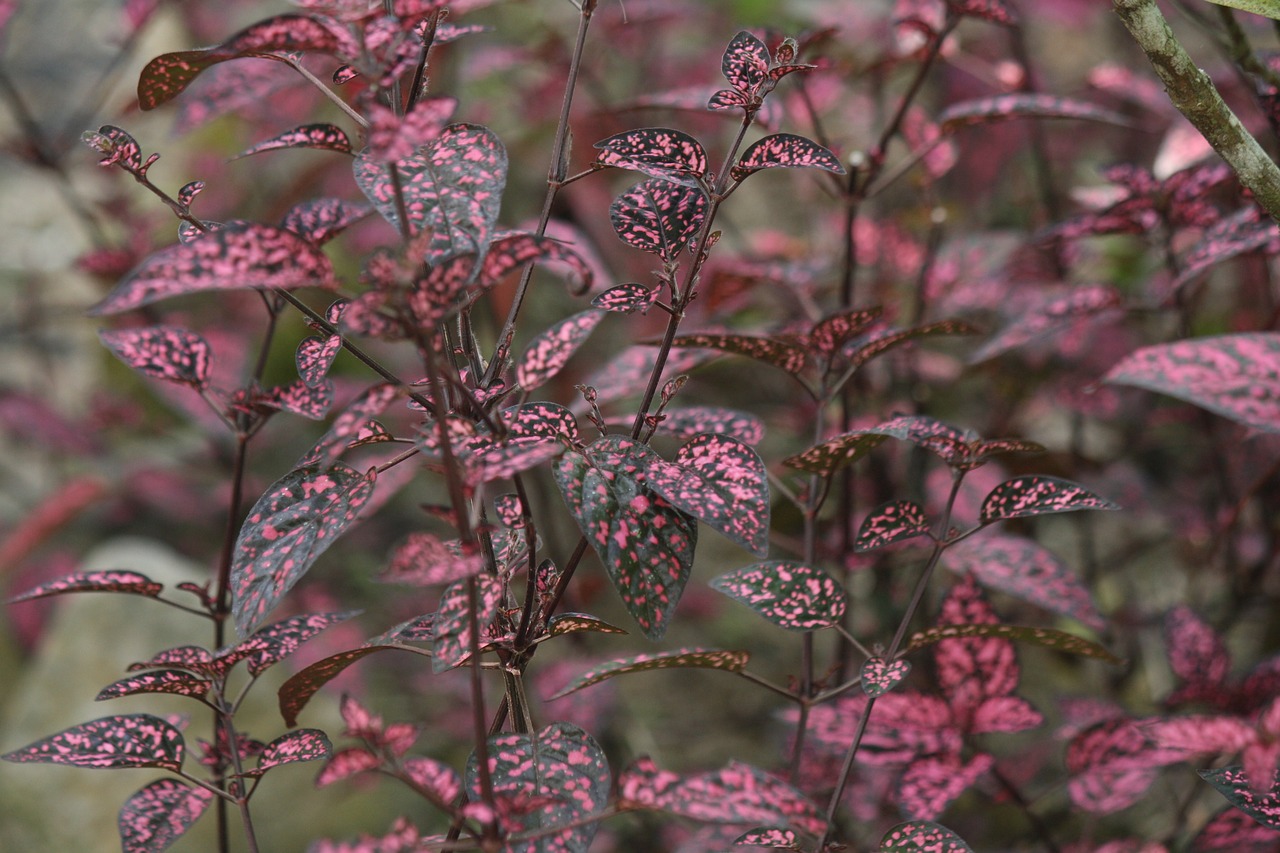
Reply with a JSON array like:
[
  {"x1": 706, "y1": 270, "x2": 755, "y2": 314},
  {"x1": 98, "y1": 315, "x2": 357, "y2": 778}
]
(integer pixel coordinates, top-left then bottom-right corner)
[{"x1": 710, "y1": 560, "x2": 846, "y2": 631}]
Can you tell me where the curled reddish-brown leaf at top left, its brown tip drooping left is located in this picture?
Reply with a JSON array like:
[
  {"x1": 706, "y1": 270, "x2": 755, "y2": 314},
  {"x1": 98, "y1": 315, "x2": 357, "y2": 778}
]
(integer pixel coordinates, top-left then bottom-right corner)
[{"x1": 138, "y1": 14, "x2": 360, "y2": 110}]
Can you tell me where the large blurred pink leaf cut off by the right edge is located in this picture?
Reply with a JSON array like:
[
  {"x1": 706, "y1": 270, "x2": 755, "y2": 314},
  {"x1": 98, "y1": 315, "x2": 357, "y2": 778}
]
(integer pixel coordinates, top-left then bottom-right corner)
[{"x1": 1102, "y1": 332, "x2": 1280, "y2": 433}]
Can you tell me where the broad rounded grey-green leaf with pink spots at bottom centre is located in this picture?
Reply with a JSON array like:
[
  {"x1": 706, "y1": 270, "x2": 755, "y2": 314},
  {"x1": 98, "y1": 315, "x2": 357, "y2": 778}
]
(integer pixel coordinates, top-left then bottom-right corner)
[{"x1": 466, "y1": 722, "x2": 612, "y2": 853}]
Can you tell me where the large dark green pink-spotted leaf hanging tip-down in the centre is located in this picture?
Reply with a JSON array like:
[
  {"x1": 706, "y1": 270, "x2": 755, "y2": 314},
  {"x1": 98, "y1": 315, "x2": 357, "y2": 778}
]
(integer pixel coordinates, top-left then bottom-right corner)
[{"x1": 556, "y1": 435, "x2": 698, "y2": 639}]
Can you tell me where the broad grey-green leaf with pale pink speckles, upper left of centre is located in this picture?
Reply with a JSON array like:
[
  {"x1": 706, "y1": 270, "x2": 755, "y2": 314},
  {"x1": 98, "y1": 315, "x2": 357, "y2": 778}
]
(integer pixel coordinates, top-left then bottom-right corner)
[{"x1": 355, "y1": 124, "x2": 507, "y2": 258}]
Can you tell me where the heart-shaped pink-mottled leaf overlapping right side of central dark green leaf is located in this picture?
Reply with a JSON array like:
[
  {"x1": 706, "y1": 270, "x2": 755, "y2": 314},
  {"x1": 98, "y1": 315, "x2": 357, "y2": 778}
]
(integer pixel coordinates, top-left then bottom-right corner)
[{"x1": 644, "y1": 434, "x2": 769, "y2": 557}]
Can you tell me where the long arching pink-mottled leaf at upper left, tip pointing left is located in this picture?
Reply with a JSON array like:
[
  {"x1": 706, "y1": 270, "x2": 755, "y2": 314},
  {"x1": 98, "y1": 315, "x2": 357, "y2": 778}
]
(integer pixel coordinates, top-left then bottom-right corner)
[{"x1": 90, "y1": 223, "x2": 333, "y2": 316}]
